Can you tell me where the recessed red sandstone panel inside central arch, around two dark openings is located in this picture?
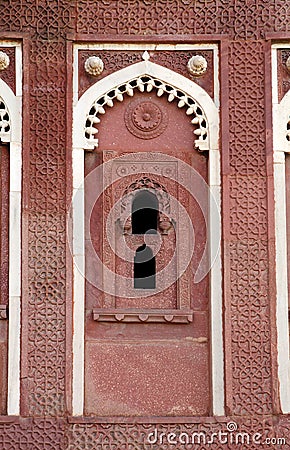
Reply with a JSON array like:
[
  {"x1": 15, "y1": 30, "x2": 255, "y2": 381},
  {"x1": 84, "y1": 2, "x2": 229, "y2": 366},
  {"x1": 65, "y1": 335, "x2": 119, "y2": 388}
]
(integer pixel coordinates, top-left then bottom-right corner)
[{"x1": 85, "y1": 81, "x2": 210, "y2": 416}]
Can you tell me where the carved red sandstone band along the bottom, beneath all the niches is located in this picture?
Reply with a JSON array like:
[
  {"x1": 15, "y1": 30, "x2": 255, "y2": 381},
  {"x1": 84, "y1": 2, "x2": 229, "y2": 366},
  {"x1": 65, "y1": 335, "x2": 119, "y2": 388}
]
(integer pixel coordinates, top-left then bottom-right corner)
[{"x1": 0, "y1": 417, "x2": 290, "y2": 450}]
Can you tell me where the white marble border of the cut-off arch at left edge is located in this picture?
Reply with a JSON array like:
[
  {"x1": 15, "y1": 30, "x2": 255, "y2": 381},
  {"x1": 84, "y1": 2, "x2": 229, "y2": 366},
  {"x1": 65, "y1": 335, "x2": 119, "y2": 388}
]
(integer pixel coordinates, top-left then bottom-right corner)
[{"x1": 0, "y1": 41, "x2": 22, "y2": 415}]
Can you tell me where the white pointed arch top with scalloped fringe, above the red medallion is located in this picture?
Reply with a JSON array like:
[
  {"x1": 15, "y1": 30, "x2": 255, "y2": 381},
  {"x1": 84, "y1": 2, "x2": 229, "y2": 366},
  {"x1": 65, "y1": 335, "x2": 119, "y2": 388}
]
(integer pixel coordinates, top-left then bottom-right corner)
[{"x1": 74, "y1": 61, "x2": 219, "y2": 150}]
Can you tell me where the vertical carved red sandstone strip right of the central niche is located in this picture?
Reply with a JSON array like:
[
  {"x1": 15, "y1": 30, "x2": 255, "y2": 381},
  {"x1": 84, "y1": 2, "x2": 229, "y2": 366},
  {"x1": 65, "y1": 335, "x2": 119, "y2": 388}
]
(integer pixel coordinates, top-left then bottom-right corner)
[{"x1": 229, "y1": 41, "x2": 272, "y2": 414}]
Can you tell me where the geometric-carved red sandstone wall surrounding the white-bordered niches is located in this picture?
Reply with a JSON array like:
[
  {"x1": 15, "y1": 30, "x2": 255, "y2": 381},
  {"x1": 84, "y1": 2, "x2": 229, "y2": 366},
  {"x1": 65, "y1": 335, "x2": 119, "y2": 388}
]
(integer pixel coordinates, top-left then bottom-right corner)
[{"x1": 0, "y1": 0, "x2": 290, "y2": 450}]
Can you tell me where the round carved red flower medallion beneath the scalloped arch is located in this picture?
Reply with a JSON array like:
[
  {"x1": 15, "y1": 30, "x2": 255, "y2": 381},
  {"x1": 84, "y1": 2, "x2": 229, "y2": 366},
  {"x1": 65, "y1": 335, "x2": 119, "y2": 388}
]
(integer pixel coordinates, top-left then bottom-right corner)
[{"x1": 124, "y1": 100, "x2": 168, "y2": 139}]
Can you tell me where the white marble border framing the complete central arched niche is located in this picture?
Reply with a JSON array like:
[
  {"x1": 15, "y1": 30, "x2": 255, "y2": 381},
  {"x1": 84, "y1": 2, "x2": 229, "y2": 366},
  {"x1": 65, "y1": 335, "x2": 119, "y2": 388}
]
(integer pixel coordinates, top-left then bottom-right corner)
[{"x1": 72, "y1": 46, "x2": 224, "y2": 416}]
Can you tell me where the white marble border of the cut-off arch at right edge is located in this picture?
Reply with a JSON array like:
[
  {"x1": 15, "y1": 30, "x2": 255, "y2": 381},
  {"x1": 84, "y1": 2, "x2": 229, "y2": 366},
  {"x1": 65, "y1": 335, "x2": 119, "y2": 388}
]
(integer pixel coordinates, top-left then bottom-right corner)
[{"x1": 272, "y1": 43, "x2": 290, "y2": 414}]
